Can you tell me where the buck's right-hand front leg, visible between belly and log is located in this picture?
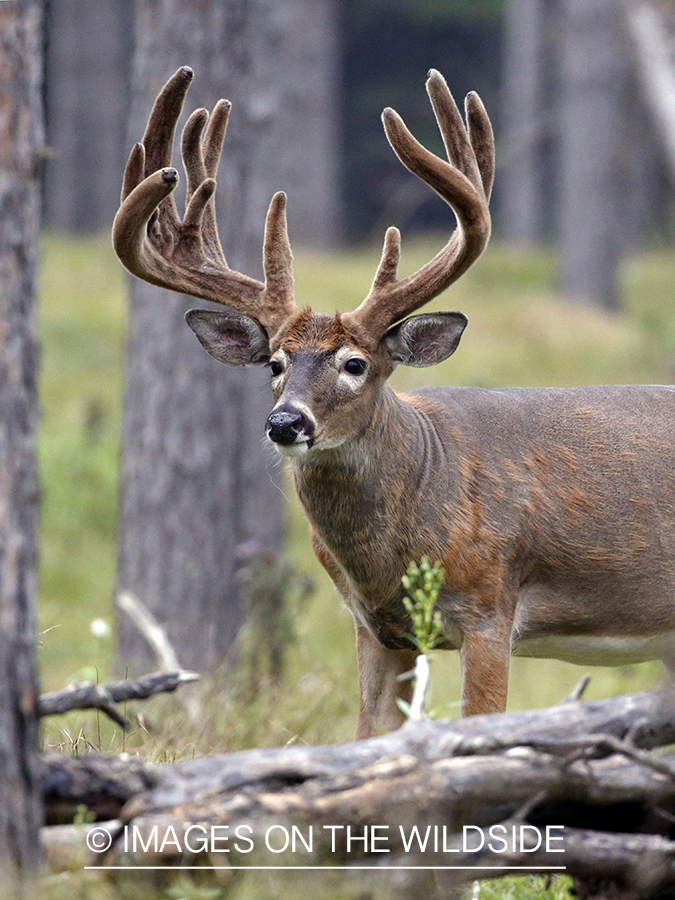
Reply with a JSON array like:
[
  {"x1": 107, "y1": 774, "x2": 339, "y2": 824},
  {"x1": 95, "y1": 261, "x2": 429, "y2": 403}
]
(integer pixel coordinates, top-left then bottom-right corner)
[{"x1": 459, "y1": 627, "x2": 511, "y2": 716}]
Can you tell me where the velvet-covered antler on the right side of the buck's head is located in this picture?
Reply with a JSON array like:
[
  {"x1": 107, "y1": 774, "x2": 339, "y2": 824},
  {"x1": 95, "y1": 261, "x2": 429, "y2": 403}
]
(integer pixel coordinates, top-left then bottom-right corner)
[{"x1": 342, "y1": 69, "x2": 494, "y2": 345}]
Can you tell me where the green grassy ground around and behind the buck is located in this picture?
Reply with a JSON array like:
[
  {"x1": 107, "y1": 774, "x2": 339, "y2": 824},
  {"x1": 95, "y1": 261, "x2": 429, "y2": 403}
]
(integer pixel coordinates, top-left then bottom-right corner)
[{"x1": 39, "y1": 229, "x2": 675, "y2": 900}]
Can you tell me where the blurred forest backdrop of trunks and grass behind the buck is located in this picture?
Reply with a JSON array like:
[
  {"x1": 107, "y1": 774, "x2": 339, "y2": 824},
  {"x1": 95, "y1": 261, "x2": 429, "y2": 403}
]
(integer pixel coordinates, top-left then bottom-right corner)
[{"x1": 1, "y1": 0, "x2": 675, "y2": 892}]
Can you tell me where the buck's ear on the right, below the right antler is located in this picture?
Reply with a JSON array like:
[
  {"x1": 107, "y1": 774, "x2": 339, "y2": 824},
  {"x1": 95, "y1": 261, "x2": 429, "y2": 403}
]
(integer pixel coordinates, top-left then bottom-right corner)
[{"x1": 382, "y1": 313, "x2": 469, "y2": 368}]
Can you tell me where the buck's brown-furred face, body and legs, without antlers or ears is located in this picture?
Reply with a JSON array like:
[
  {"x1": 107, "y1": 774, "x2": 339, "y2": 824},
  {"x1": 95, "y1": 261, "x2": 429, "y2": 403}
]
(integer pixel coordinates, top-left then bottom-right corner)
[{"x1": 270, "y1": 340, "x2": 675, "y2": 736}]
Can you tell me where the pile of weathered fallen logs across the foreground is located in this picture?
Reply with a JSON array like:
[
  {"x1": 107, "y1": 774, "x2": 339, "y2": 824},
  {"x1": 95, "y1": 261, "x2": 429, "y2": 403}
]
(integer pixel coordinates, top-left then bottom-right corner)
[{"x1": 38, "y1": 690, "x2": 675, "y2": 897}]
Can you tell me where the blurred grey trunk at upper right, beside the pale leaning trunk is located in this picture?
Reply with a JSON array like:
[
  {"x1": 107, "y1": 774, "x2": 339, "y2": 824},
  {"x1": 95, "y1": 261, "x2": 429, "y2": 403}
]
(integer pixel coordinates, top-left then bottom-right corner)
[{"x1": 560, "y1": 0, "x2": 626, "y2": 309}]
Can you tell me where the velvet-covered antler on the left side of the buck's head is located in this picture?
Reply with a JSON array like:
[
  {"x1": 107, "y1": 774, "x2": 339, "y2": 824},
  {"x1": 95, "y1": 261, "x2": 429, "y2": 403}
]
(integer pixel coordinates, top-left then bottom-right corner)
[{"x1": 113, "y1": 66, "x2": 297, "y2": 334}]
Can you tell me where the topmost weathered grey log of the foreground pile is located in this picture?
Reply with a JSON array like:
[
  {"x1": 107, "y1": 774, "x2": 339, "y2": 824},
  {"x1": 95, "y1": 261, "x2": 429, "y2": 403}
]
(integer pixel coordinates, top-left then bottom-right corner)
[{"x1": 44, "y1": 691, "x2": 675, "y2": 820}]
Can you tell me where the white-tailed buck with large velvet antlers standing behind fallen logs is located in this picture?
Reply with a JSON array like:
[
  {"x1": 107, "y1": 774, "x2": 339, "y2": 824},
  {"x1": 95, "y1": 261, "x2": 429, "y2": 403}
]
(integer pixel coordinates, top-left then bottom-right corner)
[{"x1": 113, "y1": 68, "x2": 675, "y2": 737}]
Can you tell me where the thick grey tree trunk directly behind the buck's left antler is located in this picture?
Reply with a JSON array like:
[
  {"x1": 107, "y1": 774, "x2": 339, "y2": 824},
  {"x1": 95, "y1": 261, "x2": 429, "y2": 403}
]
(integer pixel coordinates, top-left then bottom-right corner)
[{"x1": 119, "y1": 0, "x2": 335, "y2": 673}]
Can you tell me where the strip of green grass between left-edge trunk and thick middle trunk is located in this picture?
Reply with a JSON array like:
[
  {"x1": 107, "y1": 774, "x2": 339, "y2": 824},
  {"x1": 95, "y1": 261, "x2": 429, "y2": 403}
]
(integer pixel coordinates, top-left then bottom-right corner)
[{"x1": 38, "y1": 236, "x2": 126, "y2": 689}]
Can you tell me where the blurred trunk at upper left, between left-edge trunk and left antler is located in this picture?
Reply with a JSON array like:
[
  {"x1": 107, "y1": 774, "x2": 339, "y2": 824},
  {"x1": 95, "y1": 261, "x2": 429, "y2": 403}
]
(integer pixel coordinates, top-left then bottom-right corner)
[{"x1": 45, "y1": 0, "x2": 133, "y2": 232}]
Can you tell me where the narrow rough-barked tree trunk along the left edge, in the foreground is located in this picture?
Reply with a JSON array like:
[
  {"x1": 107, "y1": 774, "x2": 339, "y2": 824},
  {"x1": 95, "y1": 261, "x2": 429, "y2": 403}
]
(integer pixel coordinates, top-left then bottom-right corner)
[{"x1": 0, "y1": 0, "x2": 44, "y2": 883}]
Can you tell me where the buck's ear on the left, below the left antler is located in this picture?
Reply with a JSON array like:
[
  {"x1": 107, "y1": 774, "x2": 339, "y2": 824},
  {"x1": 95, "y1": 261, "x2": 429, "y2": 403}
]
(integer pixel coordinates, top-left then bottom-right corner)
[{"x1": 185, "y1": 309, "x2": 270, "y2": 366}]
